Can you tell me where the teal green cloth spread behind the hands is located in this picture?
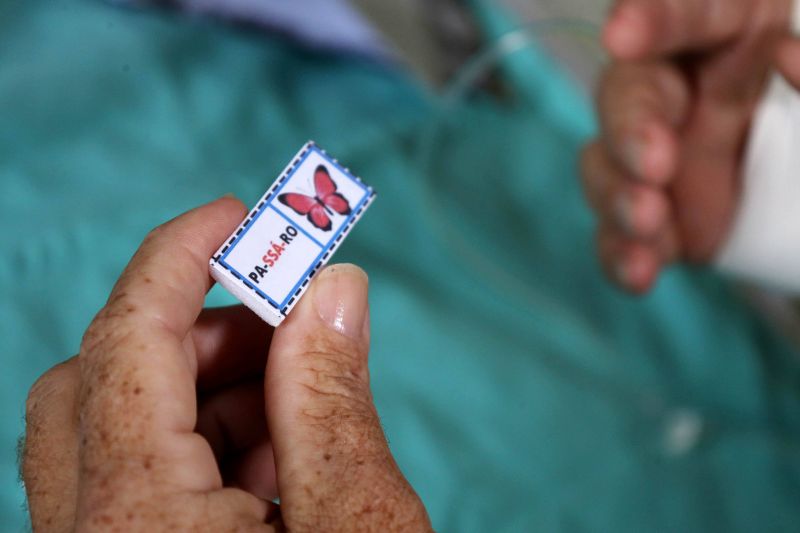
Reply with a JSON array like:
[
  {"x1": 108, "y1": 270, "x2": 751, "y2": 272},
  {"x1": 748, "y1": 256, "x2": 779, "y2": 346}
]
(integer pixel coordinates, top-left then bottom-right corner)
[{"x1": 0, "y1": 0, "x2": 800, "y2": 532}]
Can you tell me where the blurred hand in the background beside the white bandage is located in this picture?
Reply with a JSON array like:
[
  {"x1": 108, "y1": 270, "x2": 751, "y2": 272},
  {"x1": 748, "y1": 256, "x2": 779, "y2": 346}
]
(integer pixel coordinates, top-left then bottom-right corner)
[{"x1": 582, "y1": 0, "x2": 800, "y2": 293}]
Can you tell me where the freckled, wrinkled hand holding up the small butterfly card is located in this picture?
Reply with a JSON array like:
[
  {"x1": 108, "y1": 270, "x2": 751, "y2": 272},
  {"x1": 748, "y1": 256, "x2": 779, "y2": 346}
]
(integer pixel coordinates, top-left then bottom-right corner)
[{"x1": 22, "y1": 198, "x2": 431, "y2": 532}]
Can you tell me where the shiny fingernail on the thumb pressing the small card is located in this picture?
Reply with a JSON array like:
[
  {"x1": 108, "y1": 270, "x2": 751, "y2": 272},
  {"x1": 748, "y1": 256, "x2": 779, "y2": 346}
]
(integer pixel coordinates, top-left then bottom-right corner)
[{"x1": 313, "y1": 265, "x2": 369, "y2": 339}]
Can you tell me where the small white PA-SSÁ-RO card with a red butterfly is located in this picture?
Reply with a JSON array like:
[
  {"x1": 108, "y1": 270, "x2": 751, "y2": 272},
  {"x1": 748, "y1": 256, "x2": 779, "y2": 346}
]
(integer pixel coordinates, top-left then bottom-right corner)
[{"x1": 210, "y1": 142, "x2": 375, "y2": 326}]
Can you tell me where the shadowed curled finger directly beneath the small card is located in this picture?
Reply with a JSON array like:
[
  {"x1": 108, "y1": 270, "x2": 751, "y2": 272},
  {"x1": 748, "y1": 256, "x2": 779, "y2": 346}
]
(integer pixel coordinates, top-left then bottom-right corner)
[{"x1": 192, "y1": 305, "x2": 273, "y2": 392}]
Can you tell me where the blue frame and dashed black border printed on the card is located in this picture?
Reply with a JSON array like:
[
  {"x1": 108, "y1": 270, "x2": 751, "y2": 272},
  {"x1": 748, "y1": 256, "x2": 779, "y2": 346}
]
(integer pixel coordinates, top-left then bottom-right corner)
[{"x1": 218, "y1": 144, "x2": 374, "y2": 314}]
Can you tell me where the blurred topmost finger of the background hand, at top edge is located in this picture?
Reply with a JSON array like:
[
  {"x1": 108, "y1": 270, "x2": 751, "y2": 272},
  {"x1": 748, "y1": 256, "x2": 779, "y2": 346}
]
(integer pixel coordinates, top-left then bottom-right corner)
[{"x1": 603, "y1": 0, "x2": 757, "y2": 59}]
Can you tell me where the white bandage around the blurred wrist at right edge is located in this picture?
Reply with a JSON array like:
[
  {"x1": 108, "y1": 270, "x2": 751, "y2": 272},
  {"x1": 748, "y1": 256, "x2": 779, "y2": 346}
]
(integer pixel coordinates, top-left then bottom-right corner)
[{"x1": 717, "y1": 0, "x2": 800, "y2": 294}]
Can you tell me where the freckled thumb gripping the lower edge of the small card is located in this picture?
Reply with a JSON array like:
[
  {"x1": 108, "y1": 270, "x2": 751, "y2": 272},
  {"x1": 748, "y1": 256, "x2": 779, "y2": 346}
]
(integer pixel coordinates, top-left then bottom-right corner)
[{"x1": 265, "y1": 265, "x2": 430, "y2": 531}]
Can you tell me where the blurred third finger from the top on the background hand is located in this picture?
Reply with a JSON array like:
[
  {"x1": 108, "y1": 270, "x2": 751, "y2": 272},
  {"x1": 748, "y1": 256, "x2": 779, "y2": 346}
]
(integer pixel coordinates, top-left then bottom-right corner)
[{"x1": 582, "y1": 143, "x2": 670, "y2": 240}]
